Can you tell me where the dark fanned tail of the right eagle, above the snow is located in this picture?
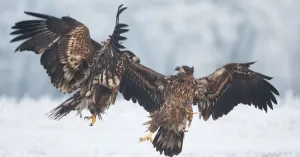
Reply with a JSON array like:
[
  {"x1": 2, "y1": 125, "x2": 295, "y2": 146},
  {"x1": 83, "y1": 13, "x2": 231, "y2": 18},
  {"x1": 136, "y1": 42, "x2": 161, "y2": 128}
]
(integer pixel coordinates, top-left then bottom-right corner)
[{"x1": 153, "y1": 127, "x2": 184, "y2": 157}]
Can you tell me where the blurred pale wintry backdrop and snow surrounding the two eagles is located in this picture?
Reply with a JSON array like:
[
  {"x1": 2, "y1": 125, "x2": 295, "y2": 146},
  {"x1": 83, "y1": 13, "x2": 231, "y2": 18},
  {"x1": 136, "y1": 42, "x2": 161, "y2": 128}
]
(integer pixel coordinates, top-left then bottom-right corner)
[{"x1": 0, "y1": 0, "x2": 300, "y2": 157}]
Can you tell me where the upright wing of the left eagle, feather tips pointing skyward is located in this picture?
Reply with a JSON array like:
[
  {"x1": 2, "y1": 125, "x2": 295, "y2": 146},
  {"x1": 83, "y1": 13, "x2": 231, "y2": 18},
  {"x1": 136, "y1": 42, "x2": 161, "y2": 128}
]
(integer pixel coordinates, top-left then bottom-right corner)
[{"x1": 88, "y1": 4, "x2": 129, "y2": 87}]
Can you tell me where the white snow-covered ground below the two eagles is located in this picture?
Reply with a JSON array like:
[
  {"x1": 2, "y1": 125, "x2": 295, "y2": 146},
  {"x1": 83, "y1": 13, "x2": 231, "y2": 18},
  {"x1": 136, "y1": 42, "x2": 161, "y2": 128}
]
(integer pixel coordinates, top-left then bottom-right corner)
[{"x1": 0, "y1": 93, "x2": 300, "y2": 157}]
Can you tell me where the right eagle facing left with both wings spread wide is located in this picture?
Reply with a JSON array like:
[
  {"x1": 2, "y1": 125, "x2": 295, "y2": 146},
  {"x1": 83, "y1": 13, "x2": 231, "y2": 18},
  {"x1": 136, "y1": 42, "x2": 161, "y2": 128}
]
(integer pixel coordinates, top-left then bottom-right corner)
[{"x1": 93, "y1": 59, "x2": 279, "y2": 156}]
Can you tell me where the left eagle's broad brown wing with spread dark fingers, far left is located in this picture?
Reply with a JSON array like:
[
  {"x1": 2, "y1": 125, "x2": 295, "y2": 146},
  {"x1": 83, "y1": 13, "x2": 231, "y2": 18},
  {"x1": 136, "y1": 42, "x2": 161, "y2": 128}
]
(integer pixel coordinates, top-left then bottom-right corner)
[{"x1": 10, "y1": 12, "x2": 102, "y2": 93}]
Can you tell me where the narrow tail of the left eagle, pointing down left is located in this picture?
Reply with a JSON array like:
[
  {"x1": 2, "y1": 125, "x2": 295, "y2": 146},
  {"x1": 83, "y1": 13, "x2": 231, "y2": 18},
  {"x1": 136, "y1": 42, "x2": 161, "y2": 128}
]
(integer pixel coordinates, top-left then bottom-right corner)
[{"x1": 47, "y1": 91, "x2": 92, "y2": 120}]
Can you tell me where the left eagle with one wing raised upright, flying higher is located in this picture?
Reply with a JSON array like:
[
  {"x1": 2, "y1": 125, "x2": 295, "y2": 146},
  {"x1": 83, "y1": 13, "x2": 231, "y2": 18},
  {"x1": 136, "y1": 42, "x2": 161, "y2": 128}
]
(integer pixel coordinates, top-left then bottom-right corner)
[{"x1": 10, "y1": 5, "x2": 139, "y2": 126}]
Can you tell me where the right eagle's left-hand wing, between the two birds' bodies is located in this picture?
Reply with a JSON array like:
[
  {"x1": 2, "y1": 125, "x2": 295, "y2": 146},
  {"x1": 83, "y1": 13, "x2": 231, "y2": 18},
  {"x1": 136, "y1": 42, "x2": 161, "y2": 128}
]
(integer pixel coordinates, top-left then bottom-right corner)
[{"x1": 119, "y1": 64, "x2": 165, "y2": 113}]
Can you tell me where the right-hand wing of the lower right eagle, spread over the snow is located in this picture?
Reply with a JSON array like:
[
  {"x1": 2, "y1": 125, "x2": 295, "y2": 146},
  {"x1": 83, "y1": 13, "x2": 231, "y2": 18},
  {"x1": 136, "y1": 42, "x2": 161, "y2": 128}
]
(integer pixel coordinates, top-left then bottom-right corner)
[{"x1": 194, "y1": 62, "x2": 279, "y2": 120}]
